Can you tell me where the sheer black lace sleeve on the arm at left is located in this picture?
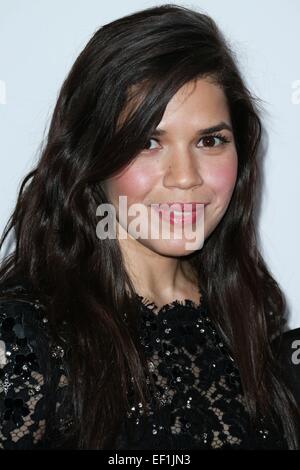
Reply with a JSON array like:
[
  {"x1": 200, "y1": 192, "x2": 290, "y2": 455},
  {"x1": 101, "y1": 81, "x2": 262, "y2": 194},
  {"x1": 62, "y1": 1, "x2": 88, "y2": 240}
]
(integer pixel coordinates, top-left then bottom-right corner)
[{"x1": 0, "y1": 299, "x2": 61, "y2": 449}]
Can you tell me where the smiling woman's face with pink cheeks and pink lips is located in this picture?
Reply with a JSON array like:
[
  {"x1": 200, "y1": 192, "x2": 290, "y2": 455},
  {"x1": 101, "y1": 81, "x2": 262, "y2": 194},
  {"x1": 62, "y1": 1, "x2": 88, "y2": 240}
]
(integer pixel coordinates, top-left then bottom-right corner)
[{"x1": 103, "y1": 79, "x2": 238, "y2": 256}]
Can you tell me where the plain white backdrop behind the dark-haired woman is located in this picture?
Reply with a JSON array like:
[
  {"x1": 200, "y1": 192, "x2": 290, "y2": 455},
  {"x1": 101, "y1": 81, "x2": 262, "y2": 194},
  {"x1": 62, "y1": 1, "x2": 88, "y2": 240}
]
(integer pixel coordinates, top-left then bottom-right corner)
[{"x1": 0, "y1": 0, "x2": 300, "y2": 328}]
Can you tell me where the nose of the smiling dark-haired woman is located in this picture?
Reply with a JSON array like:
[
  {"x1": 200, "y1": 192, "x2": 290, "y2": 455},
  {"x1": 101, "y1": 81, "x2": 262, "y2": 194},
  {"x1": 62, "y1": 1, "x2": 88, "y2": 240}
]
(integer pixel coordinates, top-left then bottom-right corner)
[{"x1": 164, "y1": 148, "x2": 203, "y2": 189}]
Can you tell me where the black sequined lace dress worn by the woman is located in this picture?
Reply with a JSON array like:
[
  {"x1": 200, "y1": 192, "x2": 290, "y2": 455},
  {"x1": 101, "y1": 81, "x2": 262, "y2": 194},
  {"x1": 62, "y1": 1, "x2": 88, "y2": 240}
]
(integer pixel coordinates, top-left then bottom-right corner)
[{"x1": 0, "y1": 285, "x2": 287, "y2": 450}]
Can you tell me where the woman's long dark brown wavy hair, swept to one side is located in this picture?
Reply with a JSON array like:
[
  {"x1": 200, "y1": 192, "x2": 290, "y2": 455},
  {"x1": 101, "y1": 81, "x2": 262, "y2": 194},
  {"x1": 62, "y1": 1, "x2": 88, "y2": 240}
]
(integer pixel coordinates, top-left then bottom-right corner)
[{"x1": 0, "y1": 4, "x2": 298, "y2": 449}]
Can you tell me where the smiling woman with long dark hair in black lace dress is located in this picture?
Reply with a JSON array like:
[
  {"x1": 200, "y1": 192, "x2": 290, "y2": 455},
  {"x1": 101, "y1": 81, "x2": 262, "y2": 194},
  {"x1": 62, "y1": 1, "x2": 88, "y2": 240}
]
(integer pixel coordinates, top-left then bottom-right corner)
[{"x1": 0, "y1": 5, "x2": 299, "y2": 449}]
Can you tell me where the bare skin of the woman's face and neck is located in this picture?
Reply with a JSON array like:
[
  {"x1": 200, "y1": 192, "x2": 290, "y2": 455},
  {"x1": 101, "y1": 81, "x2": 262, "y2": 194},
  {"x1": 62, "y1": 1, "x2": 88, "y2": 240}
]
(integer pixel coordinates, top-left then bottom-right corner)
[{"x1": 103, "y1": 78, "x2": 238, "y2": 307}]
